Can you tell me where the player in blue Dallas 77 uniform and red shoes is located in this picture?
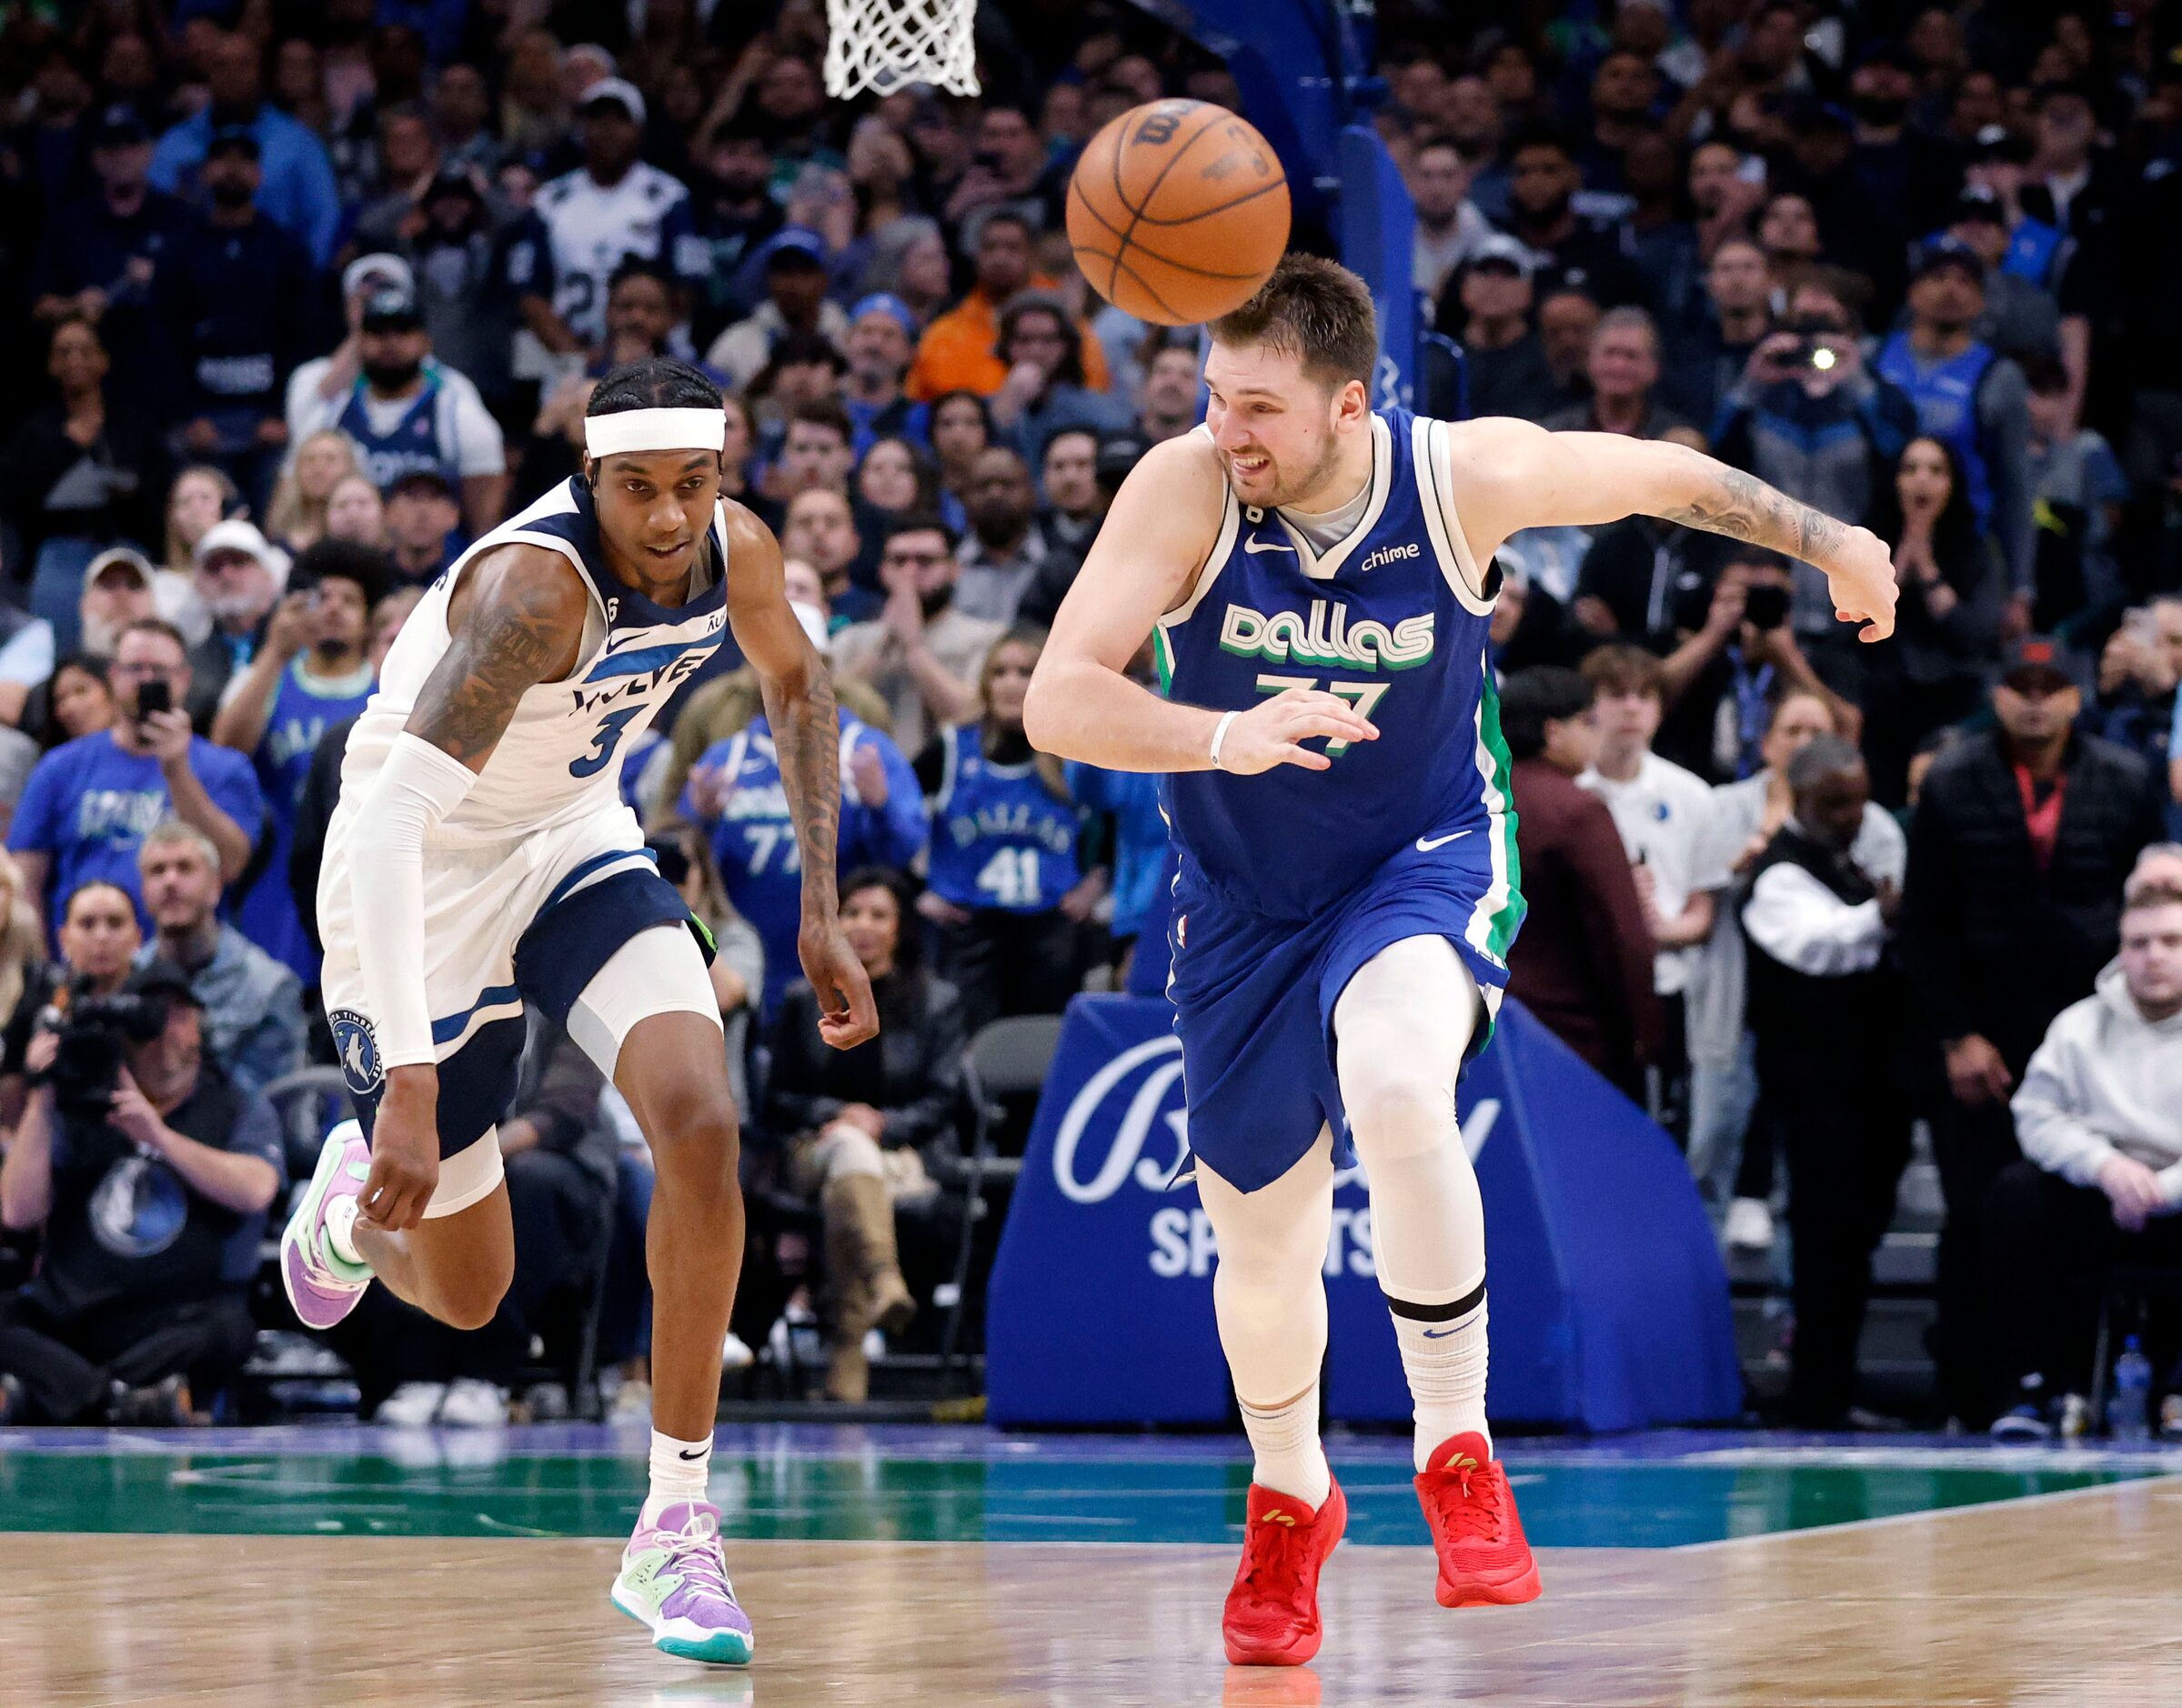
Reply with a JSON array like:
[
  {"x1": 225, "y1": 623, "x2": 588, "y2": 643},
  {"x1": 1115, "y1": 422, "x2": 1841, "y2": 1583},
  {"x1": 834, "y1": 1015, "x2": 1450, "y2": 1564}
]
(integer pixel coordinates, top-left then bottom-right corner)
[{"x1": 1028, "y1": 256, "x2": 1894, "y2": 1666}]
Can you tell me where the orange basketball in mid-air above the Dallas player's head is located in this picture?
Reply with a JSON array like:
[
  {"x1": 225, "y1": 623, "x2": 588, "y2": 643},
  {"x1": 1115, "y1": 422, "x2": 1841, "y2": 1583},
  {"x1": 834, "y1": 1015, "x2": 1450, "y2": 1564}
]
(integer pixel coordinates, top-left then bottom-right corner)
[{"x1": 1070, "y1": 100, "x2": 1287, "y2": 327}]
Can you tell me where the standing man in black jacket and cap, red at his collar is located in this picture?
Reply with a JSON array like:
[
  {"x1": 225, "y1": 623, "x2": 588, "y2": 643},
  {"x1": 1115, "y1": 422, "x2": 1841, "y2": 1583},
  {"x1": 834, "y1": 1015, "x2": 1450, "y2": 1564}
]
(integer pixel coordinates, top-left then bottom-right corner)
[{"x1": 1901, "y1": 635, "x2": 2162, "y2": 1427}]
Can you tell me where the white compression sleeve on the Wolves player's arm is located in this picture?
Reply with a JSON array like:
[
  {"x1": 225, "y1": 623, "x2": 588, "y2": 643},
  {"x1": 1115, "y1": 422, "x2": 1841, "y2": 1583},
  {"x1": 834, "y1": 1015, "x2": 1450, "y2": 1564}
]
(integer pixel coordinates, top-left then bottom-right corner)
[{"x1": 349, "y1": 730, "x2": 478, "y2": 1067}]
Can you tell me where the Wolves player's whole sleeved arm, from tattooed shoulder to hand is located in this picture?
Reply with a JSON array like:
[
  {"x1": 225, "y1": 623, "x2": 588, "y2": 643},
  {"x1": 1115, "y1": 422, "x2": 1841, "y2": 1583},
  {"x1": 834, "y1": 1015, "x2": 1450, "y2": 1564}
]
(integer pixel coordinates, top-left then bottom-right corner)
[{"x1": 349, "y1": 546, "x2": 587, "y2": 1230}]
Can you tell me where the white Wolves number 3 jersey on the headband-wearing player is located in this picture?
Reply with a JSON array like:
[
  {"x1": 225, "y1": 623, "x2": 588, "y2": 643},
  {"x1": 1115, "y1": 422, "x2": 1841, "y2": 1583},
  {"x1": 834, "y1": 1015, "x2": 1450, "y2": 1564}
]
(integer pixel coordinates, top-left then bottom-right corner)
[{"x1": 340, "y1": 477, "x2": 727, "y2": 850}]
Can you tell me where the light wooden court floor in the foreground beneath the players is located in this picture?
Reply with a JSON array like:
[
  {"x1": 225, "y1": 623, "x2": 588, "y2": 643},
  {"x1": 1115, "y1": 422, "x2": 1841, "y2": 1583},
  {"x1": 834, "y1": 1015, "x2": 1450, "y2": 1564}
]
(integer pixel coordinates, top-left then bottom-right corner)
[{"x1": 0, "y1": 1477, "x2": 2182, "y2": 1708}]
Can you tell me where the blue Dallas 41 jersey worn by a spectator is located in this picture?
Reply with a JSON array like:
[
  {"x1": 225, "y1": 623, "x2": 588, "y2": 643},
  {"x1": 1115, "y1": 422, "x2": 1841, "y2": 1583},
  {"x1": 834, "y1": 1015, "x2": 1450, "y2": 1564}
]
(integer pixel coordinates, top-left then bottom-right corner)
[{"x1": 928, "y1": 724, "x2": 1082, "y2": 914}]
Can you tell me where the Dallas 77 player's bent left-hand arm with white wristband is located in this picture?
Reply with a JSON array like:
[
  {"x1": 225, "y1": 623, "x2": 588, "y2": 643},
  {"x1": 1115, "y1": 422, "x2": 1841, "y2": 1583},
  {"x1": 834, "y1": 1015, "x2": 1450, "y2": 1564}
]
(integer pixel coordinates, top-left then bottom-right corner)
[{"x1": 1023, "y1": 437, "x2": 1379, "y2": 777}]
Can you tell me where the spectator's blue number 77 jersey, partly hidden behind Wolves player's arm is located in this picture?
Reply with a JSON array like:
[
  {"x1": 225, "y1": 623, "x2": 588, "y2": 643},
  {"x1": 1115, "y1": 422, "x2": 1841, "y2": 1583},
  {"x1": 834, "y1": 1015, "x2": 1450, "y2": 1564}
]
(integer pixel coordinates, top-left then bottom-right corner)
[{"x1": 680, "y1": 711, "x2": 925, "y2": 1019}]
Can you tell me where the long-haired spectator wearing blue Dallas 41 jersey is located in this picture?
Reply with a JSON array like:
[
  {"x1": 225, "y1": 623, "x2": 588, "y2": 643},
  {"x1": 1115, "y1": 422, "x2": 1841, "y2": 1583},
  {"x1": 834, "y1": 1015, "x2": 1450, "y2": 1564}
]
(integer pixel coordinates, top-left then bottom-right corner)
[{"x1": 917, "y1": 628, "x2": 1104, "y2": 1034}]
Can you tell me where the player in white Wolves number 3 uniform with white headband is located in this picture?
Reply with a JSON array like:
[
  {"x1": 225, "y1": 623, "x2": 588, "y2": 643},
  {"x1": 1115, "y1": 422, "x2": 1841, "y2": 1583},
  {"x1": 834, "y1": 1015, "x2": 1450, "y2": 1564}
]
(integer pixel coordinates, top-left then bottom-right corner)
[{"x1": 281, "y1": 360, "x2": 880, "y2": 1664}]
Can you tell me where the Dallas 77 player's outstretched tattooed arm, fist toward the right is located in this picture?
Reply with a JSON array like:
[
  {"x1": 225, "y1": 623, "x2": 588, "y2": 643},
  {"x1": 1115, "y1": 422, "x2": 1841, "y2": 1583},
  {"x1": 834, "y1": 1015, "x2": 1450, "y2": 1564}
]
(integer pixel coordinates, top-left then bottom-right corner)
[{"x1": 1449, "y1": 419, "x2": 1896, "y2": 641}]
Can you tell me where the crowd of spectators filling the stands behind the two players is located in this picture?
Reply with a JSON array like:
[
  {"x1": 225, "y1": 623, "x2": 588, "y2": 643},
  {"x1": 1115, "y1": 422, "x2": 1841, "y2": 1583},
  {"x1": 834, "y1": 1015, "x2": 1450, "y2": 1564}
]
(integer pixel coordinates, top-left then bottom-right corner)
[{"x1": 0, "y1": 0, "x2": 2182, "y2": 1424}]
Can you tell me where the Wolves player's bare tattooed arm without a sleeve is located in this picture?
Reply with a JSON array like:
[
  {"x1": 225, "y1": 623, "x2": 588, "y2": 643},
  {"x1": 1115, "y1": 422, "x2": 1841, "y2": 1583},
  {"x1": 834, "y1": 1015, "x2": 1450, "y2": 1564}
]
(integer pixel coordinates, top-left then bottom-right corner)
[{"x1": 727, "y1": 502, "x2": 880, "y2": 1050}]
